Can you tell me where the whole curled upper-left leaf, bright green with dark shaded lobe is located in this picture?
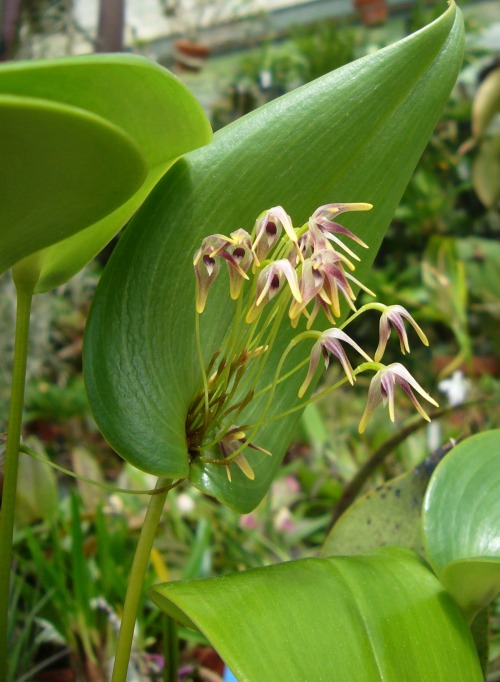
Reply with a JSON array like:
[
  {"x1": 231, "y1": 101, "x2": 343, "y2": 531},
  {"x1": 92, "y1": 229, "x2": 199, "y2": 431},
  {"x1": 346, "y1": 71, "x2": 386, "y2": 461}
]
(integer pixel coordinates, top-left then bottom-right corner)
[{"x1": 0, "y1": 55, "x2": 211, "y2": 292}]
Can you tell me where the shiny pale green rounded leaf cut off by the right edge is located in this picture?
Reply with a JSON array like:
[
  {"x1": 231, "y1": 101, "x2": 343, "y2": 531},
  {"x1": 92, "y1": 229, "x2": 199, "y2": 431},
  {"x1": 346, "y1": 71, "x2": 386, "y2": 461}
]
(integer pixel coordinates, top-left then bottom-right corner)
[{"x1": 423, "y1": 430, "x2": 500, "y2": 619}]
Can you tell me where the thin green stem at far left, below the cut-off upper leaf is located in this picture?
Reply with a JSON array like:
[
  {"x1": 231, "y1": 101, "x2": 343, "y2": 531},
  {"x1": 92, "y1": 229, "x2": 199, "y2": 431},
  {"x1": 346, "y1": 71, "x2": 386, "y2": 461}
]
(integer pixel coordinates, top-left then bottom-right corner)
[{"x1": 0, "y1": 289, "x2": 33, "y2": 682}]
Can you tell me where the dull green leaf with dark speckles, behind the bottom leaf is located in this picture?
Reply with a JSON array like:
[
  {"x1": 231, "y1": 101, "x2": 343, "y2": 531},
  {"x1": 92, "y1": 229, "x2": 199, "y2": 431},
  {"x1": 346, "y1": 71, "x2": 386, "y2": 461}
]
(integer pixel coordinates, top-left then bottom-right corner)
[{"x1": 321, "y1": 448, "x2": 446, "y2": 556}]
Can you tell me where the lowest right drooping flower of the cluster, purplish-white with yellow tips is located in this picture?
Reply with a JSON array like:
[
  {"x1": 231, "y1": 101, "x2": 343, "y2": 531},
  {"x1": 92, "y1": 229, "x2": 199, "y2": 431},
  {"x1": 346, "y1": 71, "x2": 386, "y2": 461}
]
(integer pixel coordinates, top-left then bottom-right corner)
[{"x1": 359, "y1": 362, "x2": 439, "y2": 433}]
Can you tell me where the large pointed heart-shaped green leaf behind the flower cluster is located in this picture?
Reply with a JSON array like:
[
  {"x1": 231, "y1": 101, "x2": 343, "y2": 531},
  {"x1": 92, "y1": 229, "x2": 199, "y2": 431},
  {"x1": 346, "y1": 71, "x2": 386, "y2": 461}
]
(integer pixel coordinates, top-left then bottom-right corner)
[{"x1": 85, "y1": 5, "x2": 463, "y2": 511}]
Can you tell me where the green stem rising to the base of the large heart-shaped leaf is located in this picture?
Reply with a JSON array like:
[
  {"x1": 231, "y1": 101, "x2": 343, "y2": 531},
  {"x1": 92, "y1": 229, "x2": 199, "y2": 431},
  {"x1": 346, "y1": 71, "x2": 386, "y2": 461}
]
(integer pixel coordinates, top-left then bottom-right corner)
[{"x1": 111, "y1": 478, "x2": 171, "y2": 682}]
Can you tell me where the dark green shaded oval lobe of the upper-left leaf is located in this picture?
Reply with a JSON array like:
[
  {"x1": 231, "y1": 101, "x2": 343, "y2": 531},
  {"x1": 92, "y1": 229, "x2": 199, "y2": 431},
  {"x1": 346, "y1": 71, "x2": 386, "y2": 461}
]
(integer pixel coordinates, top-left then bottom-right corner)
[{"x1": 0, "y1": 95, "x2": 147, "y2": 271}]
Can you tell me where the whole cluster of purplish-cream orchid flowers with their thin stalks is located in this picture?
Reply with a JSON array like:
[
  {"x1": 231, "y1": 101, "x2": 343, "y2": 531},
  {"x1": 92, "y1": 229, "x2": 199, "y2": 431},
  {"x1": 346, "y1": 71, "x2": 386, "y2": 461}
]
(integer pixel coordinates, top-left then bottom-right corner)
[{"x1": 186, "y1": 203, "x2": 437, "y2": 480}]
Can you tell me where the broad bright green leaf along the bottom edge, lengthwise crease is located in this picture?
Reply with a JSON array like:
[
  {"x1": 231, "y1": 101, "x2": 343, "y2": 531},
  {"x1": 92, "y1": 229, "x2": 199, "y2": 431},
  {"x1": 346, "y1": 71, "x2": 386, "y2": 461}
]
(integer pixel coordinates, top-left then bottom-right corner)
[{"x1": 151, "y1": 548, "x2": 482, "y2": 682}]
